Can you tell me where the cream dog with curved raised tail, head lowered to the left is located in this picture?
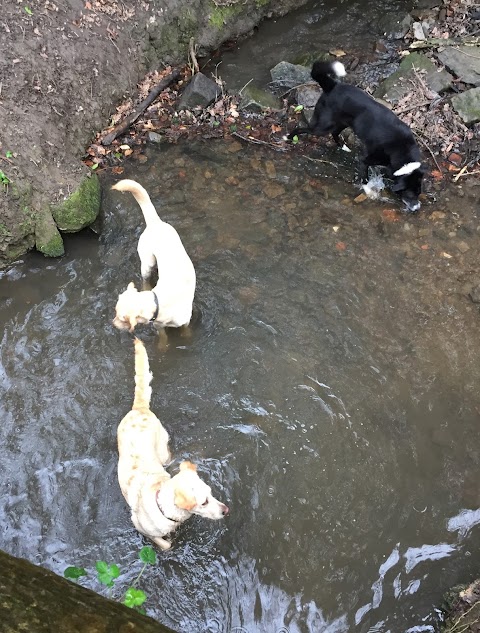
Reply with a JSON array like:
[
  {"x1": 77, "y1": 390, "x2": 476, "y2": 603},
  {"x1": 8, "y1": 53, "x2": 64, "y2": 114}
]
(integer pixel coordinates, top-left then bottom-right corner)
[{"x1": 112, "y1": 180, "x2": 196, "y2": 332}]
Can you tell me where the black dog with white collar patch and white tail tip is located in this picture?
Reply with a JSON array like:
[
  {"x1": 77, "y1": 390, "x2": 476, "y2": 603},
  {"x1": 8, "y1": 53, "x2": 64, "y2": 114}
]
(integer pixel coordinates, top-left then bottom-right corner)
[{"x1": 288, "y1": 61, "x2": 425, "y2": 213}]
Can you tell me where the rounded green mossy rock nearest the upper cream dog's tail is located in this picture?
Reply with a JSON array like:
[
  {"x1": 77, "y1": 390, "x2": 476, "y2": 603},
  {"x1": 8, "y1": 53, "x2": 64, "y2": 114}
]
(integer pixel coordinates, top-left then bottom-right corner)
[{"x1": 52, "y1": 174, "x2": 101, "y2": 233}]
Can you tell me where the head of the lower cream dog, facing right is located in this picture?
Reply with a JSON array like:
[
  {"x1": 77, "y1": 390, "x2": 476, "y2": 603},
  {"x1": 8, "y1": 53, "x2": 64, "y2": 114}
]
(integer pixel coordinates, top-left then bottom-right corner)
[{"x1": 172, "y1": 462, "x2": 228, "y2": 519}]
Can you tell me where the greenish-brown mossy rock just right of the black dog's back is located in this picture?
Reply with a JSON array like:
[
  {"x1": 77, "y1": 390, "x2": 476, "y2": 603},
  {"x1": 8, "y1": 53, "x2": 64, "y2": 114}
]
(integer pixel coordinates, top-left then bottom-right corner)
[{"x1": 374, "y1": 53, "x2": 453, "y2": 103}]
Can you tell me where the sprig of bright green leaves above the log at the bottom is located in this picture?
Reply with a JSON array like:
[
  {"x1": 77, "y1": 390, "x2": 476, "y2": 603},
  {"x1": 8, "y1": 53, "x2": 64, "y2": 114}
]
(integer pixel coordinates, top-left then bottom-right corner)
[{"x1": 63, "y1": 546, "x2": 157, "y2": 613}]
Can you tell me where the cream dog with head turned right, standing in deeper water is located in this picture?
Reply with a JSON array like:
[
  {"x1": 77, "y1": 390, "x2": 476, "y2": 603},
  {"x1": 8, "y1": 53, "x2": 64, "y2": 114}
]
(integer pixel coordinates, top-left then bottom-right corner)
[{"x1": 117, "y1": 338, "x2": 228, "y2": 550}]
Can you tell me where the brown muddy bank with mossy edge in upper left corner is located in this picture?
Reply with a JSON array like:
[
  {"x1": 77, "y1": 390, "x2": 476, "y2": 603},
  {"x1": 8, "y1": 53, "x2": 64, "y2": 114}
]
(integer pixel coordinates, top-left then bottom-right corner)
[{"x1": 0, "y1": 0, "x2": 304, "y2": 266}]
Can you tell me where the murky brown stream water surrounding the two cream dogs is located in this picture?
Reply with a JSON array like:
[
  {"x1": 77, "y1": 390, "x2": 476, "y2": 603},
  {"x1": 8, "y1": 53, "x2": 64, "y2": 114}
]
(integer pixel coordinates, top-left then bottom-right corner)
[{"x1": 0, "y1": 1, "x2": 480, "y2": 633}]
